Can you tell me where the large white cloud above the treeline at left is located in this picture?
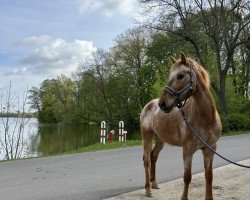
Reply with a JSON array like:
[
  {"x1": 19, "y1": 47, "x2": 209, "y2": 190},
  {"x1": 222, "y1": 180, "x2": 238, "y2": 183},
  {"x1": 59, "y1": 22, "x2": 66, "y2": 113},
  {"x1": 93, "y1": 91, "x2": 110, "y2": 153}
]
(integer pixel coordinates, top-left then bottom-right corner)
[{"x1": 7, "y1": 36, "x2": 96, "y2": 76}]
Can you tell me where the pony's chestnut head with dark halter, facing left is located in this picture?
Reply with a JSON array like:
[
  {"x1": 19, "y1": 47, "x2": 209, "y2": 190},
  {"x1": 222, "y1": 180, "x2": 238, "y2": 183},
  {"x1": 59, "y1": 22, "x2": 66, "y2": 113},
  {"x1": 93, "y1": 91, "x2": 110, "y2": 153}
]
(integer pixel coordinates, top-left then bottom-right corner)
[{"x1": 158, "y1": 52, "x2": 209, "y2": 113}]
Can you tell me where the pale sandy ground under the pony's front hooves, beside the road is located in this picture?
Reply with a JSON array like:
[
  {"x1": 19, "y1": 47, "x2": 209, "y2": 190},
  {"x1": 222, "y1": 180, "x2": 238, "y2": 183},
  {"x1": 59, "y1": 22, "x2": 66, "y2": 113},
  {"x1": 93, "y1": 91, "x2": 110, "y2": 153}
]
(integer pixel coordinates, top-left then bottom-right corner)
[{"x1": 108, "y1": 159, "x2": 250, "y2": 200}]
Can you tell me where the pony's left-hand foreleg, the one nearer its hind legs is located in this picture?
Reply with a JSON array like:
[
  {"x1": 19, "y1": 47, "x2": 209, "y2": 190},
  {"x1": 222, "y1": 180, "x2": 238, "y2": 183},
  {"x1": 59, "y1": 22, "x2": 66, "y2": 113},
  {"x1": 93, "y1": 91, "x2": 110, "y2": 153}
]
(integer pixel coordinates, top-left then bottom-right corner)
[{"x1": 181, "y1": 146, "x2": 194, "y2": 200}]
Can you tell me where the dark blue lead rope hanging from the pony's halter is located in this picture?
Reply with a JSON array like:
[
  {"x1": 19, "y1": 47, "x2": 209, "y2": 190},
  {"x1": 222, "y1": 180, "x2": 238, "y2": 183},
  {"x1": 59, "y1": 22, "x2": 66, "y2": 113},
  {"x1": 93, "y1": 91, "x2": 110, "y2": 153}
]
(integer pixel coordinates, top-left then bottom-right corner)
[{"x1": 180, "y1": 106, "x2": 250, "y2": 168}]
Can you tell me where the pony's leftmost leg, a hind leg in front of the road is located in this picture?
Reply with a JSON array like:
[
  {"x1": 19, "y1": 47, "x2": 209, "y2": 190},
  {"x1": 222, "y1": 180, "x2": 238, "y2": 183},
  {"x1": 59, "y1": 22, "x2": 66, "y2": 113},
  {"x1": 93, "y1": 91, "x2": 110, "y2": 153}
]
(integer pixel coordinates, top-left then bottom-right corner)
[{"x1": 141, "y1": 128, "x2": 153, "y2": 197}]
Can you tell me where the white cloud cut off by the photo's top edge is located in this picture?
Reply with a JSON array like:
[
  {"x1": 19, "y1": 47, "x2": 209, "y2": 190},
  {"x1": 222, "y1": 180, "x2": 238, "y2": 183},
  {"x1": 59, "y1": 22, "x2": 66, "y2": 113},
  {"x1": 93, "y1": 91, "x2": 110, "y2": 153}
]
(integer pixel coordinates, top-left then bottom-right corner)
[{"x1": 79, "y1": 0, "x2": 136, "y2": 17}]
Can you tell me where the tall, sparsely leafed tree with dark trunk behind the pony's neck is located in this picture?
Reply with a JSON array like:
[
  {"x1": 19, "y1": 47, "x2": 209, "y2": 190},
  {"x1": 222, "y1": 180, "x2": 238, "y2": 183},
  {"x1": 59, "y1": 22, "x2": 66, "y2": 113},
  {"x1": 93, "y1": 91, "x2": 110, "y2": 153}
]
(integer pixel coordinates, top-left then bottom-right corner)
[{"x1": 140, "y1": 0, "x2": 250, "y2": 116}]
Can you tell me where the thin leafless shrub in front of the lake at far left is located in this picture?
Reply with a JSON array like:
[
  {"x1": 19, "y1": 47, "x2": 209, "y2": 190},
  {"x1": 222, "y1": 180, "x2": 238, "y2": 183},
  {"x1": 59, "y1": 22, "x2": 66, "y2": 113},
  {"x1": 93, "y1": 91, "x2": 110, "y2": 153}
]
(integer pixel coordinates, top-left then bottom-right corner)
[{"x1": 0, "y1": 83, "x2": 30, "y2": 160}]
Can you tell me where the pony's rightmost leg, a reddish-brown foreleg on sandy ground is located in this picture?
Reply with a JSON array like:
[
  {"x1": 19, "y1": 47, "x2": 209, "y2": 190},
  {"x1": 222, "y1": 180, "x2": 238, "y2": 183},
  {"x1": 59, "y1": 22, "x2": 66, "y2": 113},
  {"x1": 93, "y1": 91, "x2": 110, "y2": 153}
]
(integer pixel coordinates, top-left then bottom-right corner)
[{"x1": 202, "y1": 144, "x2": 216, "y2": 200}]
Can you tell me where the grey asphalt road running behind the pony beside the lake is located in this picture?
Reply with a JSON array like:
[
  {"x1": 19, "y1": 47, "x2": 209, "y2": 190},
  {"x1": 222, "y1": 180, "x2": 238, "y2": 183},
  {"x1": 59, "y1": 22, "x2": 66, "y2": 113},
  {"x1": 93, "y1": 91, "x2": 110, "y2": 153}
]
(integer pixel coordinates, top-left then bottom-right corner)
[{"x1": 0, "y1": 134, "x2": 250, "y2": 200}]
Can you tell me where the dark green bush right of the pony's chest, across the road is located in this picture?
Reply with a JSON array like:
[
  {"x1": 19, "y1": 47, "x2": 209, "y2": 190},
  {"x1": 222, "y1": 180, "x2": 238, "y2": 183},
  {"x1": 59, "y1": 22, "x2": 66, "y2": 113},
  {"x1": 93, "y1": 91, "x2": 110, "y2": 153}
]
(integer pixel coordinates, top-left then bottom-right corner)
[{"x1": 224, "y1": 113, "x2": 250, "y2": 132}]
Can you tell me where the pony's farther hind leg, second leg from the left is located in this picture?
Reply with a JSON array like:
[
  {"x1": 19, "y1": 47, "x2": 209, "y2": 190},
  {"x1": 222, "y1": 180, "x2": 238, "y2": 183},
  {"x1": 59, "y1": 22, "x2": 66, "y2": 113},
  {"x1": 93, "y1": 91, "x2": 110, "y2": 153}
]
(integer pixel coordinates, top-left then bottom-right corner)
[{"x1": 150, "y1": 136, "x2": 164, "y2": 189}]
